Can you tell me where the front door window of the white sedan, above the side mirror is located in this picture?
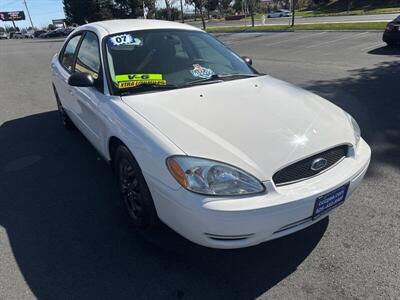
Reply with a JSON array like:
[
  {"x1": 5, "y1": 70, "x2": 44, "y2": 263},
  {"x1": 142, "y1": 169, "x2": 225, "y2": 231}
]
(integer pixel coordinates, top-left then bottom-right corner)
[{"x1": 75, "y1": 32, "x2": 101, "y2": 80}]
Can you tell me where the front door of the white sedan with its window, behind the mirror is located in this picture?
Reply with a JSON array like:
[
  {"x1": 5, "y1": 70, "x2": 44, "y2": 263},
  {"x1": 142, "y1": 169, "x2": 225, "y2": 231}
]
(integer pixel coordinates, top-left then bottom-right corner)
[{"x1": 70, "y1": 31, "x2": 108, "y2": 150}]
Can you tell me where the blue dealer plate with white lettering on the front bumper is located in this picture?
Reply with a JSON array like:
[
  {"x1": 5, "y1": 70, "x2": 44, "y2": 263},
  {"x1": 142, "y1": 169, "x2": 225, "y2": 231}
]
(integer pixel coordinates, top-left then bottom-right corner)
[{"x1": 312, "y1": 183, "x2": 349, "y2": 220}]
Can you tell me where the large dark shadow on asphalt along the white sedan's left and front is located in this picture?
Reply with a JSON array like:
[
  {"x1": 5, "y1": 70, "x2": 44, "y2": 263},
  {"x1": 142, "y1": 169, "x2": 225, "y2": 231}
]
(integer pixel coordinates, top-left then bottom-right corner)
[{"x1": 0, "y1": 112, "x2": 329, "y2": 299}]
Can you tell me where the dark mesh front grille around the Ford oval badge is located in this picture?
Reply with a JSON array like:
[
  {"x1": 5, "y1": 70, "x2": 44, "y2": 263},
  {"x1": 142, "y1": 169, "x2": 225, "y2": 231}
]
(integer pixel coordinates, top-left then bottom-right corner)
[{"x1": 272, "y1": 145, "x2": 348, "y2": 186}]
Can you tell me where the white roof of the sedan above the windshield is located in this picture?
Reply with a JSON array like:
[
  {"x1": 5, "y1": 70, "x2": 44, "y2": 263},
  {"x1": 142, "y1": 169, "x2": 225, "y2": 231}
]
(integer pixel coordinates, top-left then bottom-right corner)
[{"x1": 75, "y1": 19, "x2": 202, "y2": 37}]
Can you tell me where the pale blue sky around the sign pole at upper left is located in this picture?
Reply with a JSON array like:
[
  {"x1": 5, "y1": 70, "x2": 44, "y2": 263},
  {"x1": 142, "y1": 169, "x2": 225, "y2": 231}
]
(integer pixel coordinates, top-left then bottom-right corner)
[{"x1": 0, "y1": 0, "x2": 65, "y2": 28}]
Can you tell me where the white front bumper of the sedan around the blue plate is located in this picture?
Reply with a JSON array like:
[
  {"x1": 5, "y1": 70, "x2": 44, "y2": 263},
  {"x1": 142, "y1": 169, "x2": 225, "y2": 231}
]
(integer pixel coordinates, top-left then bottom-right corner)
[{"x1": 144, "y1": 139, "x2": 371, "y2": 249}]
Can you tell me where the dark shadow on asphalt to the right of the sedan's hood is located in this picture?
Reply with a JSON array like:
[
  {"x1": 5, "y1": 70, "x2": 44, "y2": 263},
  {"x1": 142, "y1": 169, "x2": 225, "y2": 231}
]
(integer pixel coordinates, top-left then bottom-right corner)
[{"x1": 306, "y1": 60, "x2": 400, "y2": 175}]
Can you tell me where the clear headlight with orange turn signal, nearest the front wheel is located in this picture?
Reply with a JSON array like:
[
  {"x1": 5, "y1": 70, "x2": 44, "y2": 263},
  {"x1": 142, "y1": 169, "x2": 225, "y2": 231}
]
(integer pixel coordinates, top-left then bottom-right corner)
[{"x1": 167, "y1": 156, "x2": 265, "y2": 196}]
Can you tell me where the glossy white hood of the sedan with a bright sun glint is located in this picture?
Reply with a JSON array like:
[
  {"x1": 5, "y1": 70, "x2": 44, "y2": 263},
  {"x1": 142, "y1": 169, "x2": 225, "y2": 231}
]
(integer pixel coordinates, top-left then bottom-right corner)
[{"x1": 122, "y1": 76, "x2": 354, "y2": 181}]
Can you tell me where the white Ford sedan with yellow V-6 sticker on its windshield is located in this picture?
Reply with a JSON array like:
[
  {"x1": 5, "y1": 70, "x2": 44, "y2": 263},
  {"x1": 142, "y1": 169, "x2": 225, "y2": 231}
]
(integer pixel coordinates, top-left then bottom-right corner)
[{"x1": 51, "y1": 20, "x2": 371, "y2": 248}]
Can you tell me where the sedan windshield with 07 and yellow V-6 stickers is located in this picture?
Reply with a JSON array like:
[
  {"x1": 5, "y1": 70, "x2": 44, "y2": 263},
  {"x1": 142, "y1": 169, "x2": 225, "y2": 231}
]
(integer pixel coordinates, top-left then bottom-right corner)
[{"x1": 105, "y1": 30, "x2": 256, "y2": 92}]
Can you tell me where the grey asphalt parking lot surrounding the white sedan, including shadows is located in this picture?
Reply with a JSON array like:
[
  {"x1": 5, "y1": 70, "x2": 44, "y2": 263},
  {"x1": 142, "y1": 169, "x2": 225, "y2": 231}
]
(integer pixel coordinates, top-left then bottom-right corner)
[{"x1": 0, "y1": 32, "x2": 400, "y2": 300}]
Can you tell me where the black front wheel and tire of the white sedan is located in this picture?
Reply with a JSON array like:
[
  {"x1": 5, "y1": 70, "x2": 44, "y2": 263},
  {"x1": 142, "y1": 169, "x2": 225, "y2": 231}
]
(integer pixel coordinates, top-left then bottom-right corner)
[{"x1": 113, "y1": 145, "x2": 159, "y2": 231}]
